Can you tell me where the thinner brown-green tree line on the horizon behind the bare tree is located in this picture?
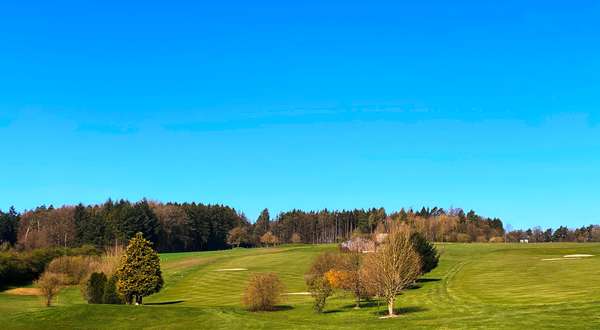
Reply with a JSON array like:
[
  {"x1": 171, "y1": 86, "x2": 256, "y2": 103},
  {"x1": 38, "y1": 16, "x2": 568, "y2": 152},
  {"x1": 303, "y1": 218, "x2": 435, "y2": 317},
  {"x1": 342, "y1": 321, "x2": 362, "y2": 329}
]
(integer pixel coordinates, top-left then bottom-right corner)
[{"x1": 244, "y1": 207, "x2": 504, "y2": 244}]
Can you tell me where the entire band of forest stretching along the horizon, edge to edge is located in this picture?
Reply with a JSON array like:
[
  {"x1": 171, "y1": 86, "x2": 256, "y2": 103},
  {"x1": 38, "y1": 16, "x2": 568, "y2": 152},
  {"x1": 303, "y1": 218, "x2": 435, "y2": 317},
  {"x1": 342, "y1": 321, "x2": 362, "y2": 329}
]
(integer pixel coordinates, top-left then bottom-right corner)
[{"x1": 0, "y1": 200, "x2": 600, "y2": 251}]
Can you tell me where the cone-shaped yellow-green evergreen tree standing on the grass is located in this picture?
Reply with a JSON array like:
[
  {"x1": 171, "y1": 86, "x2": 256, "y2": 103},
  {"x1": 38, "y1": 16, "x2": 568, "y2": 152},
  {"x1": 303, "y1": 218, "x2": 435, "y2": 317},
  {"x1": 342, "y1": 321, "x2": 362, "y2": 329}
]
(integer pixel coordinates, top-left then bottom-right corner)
[{"x1": 116, "y1": 233, "x2": 163, "y2": 305}]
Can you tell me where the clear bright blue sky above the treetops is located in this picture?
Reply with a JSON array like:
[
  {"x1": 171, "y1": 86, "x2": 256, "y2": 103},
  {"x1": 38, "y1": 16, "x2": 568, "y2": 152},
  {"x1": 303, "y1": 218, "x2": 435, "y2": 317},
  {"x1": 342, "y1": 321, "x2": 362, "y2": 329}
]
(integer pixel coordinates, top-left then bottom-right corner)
[{"x1": 0, "y1": 1, "x2": 600, "y2": 228}]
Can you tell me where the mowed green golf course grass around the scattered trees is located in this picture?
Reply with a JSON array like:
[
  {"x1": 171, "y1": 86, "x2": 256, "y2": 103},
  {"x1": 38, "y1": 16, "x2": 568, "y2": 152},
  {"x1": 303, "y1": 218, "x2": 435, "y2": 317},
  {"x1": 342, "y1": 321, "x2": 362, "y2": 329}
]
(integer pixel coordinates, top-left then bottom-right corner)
[{"x1": 0, "y1": 243, "x2": 600, "y2": 329}]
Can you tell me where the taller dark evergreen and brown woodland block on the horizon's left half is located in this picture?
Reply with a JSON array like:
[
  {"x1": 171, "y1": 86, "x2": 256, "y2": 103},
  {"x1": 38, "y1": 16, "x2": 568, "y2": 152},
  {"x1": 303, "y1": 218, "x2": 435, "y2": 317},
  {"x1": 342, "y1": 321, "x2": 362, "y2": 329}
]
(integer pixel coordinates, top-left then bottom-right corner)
[{"x1": 0, "y1": 200, "x2": 249, "y2": 251}]
